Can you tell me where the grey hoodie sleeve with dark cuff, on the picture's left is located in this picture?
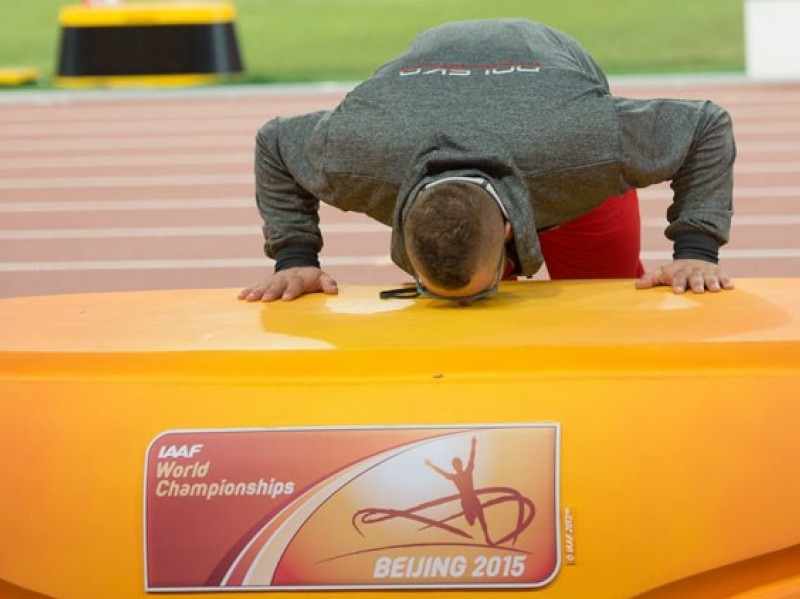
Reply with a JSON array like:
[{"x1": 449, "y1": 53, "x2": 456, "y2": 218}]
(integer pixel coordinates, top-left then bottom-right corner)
[{"x1": 255, "y1": 112, "x2": 332, "y2": 272}]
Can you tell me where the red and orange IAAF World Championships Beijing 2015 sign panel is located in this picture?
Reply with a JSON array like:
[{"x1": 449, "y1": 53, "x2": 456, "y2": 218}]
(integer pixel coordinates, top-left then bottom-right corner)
[{"x1": 145, "y1": 424, "x2": 560, "y2": 592}]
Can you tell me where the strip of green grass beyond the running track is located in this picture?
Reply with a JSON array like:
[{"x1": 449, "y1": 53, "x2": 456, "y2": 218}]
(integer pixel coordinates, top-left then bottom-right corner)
[{"x1": 0, "y1": 0, "x2": 744, "y2": 86}]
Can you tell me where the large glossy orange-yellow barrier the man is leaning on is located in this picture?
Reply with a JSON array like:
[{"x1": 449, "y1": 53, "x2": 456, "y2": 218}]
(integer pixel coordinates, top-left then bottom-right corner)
[{"x1": 0, "y1": 279, "x2": 800, "y2": 599}]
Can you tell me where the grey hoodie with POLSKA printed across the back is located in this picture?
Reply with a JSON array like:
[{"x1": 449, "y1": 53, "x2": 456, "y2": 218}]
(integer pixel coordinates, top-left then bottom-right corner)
[{"x1": 256, "y1": 19, "x2": 736, "y2": 275}]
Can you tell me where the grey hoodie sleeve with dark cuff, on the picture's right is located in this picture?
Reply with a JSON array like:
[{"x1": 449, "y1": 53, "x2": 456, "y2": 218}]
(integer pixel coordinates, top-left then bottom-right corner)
[{"x1": 614, "y1": 98, "x2": 736, "y2": 262}]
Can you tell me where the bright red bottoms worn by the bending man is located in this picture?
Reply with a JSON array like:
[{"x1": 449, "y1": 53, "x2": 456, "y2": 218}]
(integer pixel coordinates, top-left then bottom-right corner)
[{"x1": 539, "y1": 189, "x2": 644, "y2": 279}]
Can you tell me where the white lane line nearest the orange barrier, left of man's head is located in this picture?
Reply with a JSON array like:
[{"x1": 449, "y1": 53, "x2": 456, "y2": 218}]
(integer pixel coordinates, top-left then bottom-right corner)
[{"x1": 0, "y1": 255, "x2": 392, "y2": 272}]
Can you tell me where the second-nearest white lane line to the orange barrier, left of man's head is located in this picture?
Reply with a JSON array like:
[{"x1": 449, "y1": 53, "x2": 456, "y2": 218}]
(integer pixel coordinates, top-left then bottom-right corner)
[{"x1": 0, "y1": 222, "x2": 390, "y2": 240}]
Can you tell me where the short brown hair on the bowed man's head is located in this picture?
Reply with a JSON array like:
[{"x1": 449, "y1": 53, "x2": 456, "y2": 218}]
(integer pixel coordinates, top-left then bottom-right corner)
[{"x1": 403, "y1": 181, "x2": 502, "y2": 289}]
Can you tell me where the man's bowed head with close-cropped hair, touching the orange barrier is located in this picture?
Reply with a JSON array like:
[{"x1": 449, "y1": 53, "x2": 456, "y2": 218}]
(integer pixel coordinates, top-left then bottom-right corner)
[{"x1": 403, "y1": 179, "x2": 510, "y2": 299}]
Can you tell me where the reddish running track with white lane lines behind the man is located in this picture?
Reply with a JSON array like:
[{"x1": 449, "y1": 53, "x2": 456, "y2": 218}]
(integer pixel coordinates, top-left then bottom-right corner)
[{"x1": 0, "y1": 78, "x2": 800, "y2": 297}]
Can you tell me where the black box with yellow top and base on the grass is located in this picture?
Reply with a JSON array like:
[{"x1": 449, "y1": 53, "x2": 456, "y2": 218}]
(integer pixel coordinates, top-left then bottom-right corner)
[{"x1": 55, "y1": 1, "x2": 243, "y2": 88}]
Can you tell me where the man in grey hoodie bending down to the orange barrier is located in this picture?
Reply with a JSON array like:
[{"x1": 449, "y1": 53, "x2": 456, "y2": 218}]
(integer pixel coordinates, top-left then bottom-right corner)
[{"x1": 239, "y1": 19, "x2": 736, "y2": 302}]
